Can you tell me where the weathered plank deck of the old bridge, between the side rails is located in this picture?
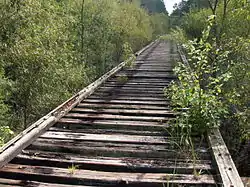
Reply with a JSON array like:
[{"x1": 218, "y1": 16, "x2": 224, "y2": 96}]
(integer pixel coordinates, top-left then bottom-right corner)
[{"x1": 0, "y1": 42, "x2": 242, "y2": 187}]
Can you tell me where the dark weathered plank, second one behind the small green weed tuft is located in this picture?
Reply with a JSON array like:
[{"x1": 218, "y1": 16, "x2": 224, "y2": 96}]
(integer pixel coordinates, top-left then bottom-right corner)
[{"x1": 28, "y1": 138, "x2": 211, "y2": 160}]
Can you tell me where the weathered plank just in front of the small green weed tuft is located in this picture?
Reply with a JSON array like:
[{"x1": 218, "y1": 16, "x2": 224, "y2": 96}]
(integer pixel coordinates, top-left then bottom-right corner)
[{"x1": 0, "y1": 164, "x2": 215, "y2": 187}]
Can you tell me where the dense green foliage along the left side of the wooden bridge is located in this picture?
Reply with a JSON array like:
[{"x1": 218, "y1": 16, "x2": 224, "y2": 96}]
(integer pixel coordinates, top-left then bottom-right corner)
[{"x1": 0, "y1": 0, "x2": 168, "y2": 143}]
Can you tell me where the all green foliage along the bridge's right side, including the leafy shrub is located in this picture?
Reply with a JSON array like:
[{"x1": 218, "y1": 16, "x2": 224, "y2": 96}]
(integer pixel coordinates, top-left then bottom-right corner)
[{"x1": 166, "y1": 0, "x2": 250, "y2": 174}]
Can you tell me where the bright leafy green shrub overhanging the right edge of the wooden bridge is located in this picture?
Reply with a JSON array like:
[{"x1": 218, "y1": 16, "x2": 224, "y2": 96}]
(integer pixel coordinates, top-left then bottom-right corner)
[{"x1": 165, "y1": 17, "x2": 231, "y2": 141}]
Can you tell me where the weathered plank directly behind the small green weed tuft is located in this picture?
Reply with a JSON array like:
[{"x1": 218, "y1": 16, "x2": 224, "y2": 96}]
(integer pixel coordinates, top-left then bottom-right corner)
[{"x1": 12, "y1": 151, "x2": 214, "y2": 174}]
